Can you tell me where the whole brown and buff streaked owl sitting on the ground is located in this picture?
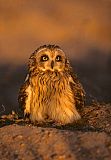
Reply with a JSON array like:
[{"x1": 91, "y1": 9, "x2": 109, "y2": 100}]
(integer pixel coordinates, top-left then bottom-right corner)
[{"x1": 18, "y1": 45, "x2": 85, "y2": 125}]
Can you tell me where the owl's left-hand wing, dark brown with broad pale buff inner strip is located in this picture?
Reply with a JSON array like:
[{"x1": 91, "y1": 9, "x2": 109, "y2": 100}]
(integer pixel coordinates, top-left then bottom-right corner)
[{"x1": 18, "y1": 75, "x2": 32, "y2": 115}]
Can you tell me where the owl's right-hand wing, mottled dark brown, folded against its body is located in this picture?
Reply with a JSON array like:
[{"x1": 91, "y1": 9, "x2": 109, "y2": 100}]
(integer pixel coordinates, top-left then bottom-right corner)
[{"x1": 69, "y1": 72, "x2": 85, "y2": 109}]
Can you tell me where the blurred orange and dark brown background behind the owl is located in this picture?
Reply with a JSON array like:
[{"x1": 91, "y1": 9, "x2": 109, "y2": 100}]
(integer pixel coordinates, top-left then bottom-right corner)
[{"x1": 0, "y1": 0, "x2": 111, "y2": 114}]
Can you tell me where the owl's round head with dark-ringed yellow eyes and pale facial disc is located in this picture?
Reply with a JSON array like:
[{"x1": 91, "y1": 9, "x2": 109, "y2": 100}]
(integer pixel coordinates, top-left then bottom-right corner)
[{"x1": 29, "y1": 45, "x2": 68, "y2": 72}]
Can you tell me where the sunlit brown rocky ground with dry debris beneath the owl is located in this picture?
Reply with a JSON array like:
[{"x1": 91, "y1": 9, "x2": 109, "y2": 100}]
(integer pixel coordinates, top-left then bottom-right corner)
[{"x1": 0, "y1": 103, "x2": 111, "y2": 160}]
